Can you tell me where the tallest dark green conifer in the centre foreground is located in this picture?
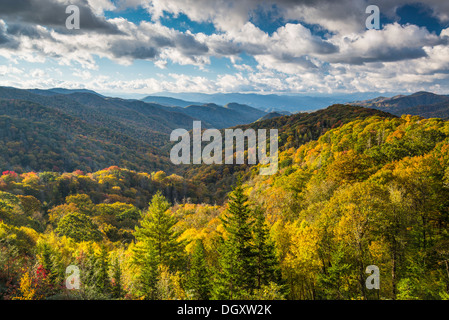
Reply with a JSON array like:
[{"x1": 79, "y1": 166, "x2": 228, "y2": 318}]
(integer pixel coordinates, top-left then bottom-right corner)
[{"x1": 214, "y1": 184, "x2": 256, "y2": 299}]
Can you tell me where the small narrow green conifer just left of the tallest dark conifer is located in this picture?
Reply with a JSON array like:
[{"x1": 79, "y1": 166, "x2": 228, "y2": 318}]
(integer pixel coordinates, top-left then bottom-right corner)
[{"x1": 187, "y1": 240, "x2": 211, "y2": 300}]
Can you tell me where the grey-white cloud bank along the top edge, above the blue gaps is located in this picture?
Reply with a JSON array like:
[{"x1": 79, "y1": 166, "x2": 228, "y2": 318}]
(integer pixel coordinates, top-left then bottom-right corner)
[{"x1": 119, "y1": 0, "x2": 449, "y2": 33}]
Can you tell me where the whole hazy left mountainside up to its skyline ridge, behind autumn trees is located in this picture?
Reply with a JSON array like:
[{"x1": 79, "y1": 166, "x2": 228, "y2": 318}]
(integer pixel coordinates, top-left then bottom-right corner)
[{"x1": 0, "y1": 87, "x2": 265, "y2": 173}]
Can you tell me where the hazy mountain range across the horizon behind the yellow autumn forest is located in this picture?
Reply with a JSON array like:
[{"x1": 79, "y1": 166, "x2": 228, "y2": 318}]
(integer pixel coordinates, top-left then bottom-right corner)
[{"x1": 0, "y1": 87, "x2": 449, "y2": 175}]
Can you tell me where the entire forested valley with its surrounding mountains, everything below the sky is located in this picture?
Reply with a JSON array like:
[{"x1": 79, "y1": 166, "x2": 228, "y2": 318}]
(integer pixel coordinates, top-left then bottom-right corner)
[{"x1": 0, "y1": 88, "x2": 449, "y2": 300}]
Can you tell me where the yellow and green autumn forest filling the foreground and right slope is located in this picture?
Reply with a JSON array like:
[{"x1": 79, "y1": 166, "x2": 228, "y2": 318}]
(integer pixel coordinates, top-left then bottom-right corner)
[{"x1": 0, "y1": 113, "x2": 449, "y2": 300}]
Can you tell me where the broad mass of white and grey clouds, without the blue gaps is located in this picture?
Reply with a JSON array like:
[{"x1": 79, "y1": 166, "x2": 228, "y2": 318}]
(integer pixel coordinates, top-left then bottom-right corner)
[{"x1": 0, "y1": 0, "x2": 449, "y2": 93}]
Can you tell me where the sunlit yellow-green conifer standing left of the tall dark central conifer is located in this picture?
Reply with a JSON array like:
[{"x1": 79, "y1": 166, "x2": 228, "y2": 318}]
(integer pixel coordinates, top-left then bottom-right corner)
[{"x1": 136, "y1": 192, "x2": 182, "y2": 270}]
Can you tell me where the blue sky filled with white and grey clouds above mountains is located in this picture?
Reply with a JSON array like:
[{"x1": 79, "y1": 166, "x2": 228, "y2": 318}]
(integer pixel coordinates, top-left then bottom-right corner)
[{"x1": 0, "y1": 0, "x2": 449, "y2": 95}]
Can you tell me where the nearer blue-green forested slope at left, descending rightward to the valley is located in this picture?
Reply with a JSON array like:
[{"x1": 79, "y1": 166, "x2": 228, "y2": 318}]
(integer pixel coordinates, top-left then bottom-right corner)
[{"x1": 0, "y1": 100, "x2": 171, "y2": 173}]
